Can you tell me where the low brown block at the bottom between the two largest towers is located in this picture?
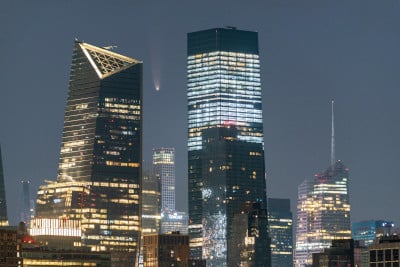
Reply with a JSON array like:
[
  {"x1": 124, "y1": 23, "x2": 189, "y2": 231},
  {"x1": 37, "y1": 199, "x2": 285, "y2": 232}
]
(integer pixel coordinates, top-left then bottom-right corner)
[{"x1": 143, "y1": 232, "x2": 189, "y2": 267}]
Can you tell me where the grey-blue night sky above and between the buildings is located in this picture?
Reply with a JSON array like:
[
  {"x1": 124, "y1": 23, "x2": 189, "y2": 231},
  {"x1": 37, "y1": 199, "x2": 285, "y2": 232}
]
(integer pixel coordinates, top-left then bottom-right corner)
[{"x1": 0, "y1": 0, "x2": 400, "y2": 228}]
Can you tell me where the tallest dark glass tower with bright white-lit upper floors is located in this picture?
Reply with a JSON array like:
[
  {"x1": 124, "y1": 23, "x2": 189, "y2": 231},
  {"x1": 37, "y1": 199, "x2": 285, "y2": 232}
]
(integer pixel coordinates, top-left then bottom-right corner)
[{"x1": 187, "y1": 27, "x2": 270, "y2": 267}]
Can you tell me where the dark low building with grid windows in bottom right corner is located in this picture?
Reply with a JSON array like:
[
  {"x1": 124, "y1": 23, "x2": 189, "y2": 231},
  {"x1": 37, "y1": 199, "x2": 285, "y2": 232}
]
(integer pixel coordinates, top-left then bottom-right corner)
[{"x1": 368, "y1": 235, "x2": 400, "y2": 267}]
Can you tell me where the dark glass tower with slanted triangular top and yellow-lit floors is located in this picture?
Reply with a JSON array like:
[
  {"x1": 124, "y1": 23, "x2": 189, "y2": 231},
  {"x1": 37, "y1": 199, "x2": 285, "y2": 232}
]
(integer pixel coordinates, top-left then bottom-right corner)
[{"x1": 35, "y1": 41, "x2": 142, "y2": 266}]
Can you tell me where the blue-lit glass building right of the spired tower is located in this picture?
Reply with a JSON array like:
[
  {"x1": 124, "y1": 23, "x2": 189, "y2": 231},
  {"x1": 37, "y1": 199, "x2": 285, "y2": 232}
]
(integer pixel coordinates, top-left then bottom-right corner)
[{"x1": 351, "y1": 220, "x2": 394, "y2": 246}]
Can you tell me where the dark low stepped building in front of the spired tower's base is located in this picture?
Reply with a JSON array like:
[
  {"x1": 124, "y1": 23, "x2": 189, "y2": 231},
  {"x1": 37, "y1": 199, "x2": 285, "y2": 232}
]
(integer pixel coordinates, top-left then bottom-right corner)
[{"x1": 312, "y1": 239, "x2": 354, "y2": 267}]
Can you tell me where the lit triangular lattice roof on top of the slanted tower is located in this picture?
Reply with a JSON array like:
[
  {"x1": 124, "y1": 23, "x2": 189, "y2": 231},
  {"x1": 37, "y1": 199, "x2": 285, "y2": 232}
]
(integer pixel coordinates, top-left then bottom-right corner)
[{"x1": 77, "y1": 41, "x2": 141, "y2": 79}]
